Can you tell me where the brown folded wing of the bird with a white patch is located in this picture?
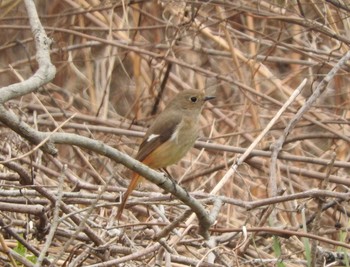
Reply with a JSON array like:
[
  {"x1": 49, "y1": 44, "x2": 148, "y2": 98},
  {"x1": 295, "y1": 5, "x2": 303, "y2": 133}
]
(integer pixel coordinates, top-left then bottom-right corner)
[{"x1": 136, "y1": 112, "x2": 182, "y2": 162}]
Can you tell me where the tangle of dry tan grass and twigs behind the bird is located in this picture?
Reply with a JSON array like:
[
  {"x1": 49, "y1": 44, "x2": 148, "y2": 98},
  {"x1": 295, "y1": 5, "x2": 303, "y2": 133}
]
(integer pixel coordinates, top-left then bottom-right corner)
[{"x1": 0, "y1": 0, "x2": 350, "y2": 266}]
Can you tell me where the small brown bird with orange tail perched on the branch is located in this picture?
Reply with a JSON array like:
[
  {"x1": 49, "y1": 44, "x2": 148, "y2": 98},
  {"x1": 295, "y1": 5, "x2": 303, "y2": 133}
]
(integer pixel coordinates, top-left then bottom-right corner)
[{"x1": 117, "y1": 89, "x2": 215, "y2": 220}]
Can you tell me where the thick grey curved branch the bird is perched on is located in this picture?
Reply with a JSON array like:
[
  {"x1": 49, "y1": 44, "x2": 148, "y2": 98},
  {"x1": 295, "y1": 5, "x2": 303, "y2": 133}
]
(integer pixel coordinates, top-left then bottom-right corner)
[{"x1": 0, "y1": 108, "x2": 214, "y2": 238}]
